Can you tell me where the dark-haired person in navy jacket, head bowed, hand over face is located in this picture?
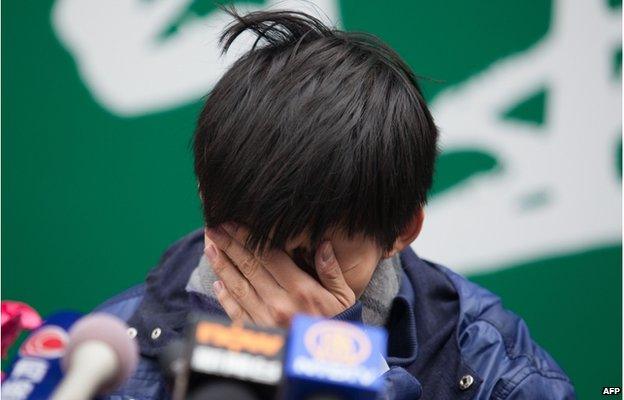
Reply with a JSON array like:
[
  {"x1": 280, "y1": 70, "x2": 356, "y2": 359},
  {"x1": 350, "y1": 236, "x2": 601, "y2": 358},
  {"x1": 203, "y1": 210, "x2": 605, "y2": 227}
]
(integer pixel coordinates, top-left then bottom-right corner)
[{"x1": 100, "y1": 7, "x2": 574, "y2": 399}]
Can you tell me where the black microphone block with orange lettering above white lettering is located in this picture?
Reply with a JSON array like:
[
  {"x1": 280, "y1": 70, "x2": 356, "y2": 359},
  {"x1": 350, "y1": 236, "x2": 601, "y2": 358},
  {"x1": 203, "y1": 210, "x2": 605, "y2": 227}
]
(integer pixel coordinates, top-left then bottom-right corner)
[{"x1": 177, "y1": 315, "x2": 286, "y2": 400}]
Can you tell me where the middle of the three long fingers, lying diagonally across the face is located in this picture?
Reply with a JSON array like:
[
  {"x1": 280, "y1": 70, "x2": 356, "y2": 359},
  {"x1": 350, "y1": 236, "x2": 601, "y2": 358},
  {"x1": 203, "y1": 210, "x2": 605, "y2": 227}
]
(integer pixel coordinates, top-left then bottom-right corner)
[{"x1": 205, "y1": 234, "x2": 271, "y2": 323}]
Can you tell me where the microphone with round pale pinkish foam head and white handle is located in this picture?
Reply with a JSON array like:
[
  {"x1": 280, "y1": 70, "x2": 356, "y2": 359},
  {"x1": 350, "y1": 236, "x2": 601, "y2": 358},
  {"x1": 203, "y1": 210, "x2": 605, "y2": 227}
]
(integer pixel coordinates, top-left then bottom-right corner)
[{"x1": 52, "y1": 313, "x2": 139, "y2": 400}]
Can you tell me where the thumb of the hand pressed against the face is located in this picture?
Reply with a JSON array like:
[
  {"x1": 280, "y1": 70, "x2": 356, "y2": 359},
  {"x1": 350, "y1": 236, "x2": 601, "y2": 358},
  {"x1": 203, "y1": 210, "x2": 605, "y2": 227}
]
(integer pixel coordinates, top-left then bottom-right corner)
[{"x1": 315, "y1": 241, "x2": 355, "y2": 307}]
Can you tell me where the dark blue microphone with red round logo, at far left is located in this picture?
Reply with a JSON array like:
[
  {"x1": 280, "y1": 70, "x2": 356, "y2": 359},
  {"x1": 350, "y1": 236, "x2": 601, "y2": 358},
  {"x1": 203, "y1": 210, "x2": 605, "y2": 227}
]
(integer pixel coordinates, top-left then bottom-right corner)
[{"x1": 0, "y1": 311, "x2": 81, "y2": 400}]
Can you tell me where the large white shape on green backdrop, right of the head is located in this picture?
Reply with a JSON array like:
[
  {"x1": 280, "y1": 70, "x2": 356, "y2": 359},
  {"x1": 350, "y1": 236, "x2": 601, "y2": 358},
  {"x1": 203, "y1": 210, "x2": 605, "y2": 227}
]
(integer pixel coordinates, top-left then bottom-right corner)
[{"x1": 415, "y1": 0, "x2": 622, "y2": 272}]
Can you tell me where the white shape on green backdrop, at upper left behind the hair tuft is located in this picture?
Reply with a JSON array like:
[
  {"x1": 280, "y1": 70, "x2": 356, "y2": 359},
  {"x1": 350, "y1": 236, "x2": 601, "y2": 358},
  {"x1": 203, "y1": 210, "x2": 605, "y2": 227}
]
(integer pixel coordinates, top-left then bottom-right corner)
[{"x1": 52, "y1": 0, "x2": 338, "y2": 116}]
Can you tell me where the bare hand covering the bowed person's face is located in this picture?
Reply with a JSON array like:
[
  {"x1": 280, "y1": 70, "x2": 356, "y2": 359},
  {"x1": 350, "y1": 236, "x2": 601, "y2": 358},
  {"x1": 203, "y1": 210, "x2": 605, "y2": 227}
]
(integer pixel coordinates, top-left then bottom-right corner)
[{"x1": 204, "y1": 224, "x2": 355, "y2": 327}]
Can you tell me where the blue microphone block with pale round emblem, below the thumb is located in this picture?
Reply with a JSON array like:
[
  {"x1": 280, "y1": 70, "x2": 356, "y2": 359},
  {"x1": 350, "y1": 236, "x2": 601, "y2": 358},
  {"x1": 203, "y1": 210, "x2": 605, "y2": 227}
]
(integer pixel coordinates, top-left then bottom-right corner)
[{"x1": 284, "y1": 315, "x2": 388, "y2": 400}]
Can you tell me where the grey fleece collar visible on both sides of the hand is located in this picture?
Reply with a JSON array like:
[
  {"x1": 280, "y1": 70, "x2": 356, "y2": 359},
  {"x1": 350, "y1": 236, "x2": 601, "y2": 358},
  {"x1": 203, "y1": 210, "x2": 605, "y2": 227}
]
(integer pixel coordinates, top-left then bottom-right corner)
[{"x1": 186, "y1": 253, "x2": 401, "y2": 326}]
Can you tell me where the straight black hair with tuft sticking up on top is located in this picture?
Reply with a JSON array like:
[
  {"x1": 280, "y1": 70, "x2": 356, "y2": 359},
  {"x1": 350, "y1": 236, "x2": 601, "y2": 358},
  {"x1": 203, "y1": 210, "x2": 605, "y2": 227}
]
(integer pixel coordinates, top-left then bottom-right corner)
[{"x1": 193, "y1": 9, "x2": 438, "y2": 251}]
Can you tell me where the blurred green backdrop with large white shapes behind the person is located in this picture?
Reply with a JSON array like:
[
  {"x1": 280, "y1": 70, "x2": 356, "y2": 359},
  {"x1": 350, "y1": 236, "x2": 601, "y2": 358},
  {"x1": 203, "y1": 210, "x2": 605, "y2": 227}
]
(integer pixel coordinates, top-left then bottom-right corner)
[{"x1": 1, "y1": 0, "x2": 622, "y2": 398}]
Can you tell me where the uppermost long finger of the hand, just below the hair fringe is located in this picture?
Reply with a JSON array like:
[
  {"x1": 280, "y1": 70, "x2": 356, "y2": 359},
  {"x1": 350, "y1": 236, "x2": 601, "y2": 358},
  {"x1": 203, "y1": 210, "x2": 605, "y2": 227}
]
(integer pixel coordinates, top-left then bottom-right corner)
[{"x1": 206, "y1": 224, "x2": 283, "y2": 297}]
